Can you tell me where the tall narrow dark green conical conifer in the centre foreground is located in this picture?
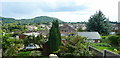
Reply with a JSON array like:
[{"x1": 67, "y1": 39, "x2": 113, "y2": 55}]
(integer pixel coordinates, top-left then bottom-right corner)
[{"x1": 48, "y1": 20, "x2": 61, "y2": 53}]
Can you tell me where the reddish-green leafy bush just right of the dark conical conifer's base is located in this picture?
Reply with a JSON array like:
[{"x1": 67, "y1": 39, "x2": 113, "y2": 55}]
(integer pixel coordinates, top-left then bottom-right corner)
[{"x1": 59, "y1": 36, "x2": 93, "y2": 56}]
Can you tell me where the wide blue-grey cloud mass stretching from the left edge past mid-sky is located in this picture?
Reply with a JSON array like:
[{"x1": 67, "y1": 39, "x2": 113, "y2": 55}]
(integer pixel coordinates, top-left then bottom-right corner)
[{"x1": 2, "y1": 1, "x2": 87, "y2": 18}]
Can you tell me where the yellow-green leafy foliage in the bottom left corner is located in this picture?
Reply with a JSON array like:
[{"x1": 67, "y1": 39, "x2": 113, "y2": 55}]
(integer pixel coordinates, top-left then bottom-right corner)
[{"x1": 2, "y1": 34, "x2": 23, "y2": 56}]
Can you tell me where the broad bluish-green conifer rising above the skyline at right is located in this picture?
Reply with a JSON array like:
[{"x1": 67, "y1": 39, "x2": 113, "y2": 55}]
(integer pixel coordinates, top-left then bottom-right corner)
[{"x1": 87, "y1": 11, "x2": 111, "y2": 35}]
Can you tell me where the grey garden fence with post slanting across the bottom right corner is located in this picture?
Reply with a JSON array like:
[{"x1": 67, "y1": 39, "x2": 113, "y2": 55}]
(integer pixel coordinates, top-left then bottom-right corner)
[{"x1": 89, "y1": 46, "x2": 120, "y2": 58}]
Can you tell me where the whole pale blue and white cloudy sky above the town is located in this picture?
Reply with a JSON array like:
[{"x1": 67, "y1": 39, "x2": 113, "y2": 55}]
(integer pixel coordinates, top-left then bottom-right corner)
[{"x1": 0, "y1": 0, "x2": 120, "y2": 22}]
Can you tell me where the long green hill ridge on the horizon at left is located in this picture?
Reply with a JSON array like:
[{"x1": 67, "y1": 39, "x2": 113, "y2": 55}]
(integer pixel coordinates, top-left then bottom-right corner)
[{"x1": 0, "y1": 16, "x2": 63, "y2": 24}]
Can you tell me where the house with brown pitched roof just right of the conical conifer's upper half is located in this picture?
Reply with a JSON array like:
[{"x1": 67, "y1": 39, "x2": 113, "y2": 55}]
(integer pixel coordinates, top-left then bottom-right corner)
[{"x1": 60, "y1": 24, "x2": 76, "y2": 36}]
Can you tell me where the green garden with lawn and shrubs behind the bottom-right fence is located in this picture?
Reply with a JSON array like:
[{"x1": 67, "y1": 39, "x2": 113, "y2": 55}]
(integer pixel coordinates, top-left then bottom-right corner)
[{"x1": 91, "y1": 35, "x2": 120, "y2": 54}]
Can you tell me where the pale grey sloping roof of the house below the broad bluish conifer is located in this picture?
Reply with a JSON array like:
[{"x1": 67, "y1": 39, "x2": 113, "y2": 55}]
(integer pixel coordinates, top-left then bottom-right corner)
[{"x1": 78, "y1": 32, "x2": 101, "y2": 39}]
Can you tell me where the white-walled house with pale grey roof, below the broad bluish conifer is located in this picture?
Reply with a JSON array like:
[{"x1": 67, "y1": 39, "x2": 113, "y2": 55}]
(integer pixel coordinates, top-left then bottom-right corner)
[{"x1": 78, "y1": 32, "x2": 101, "y2": 43}]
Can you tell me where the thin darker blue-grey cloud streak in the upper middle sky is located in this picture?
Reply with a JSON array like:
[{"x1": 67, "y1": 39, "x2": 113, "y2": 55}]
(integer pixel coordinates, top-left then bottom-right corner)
[{"x1": 42, "y1": 5, "x2": 87, "y2": 12}]
